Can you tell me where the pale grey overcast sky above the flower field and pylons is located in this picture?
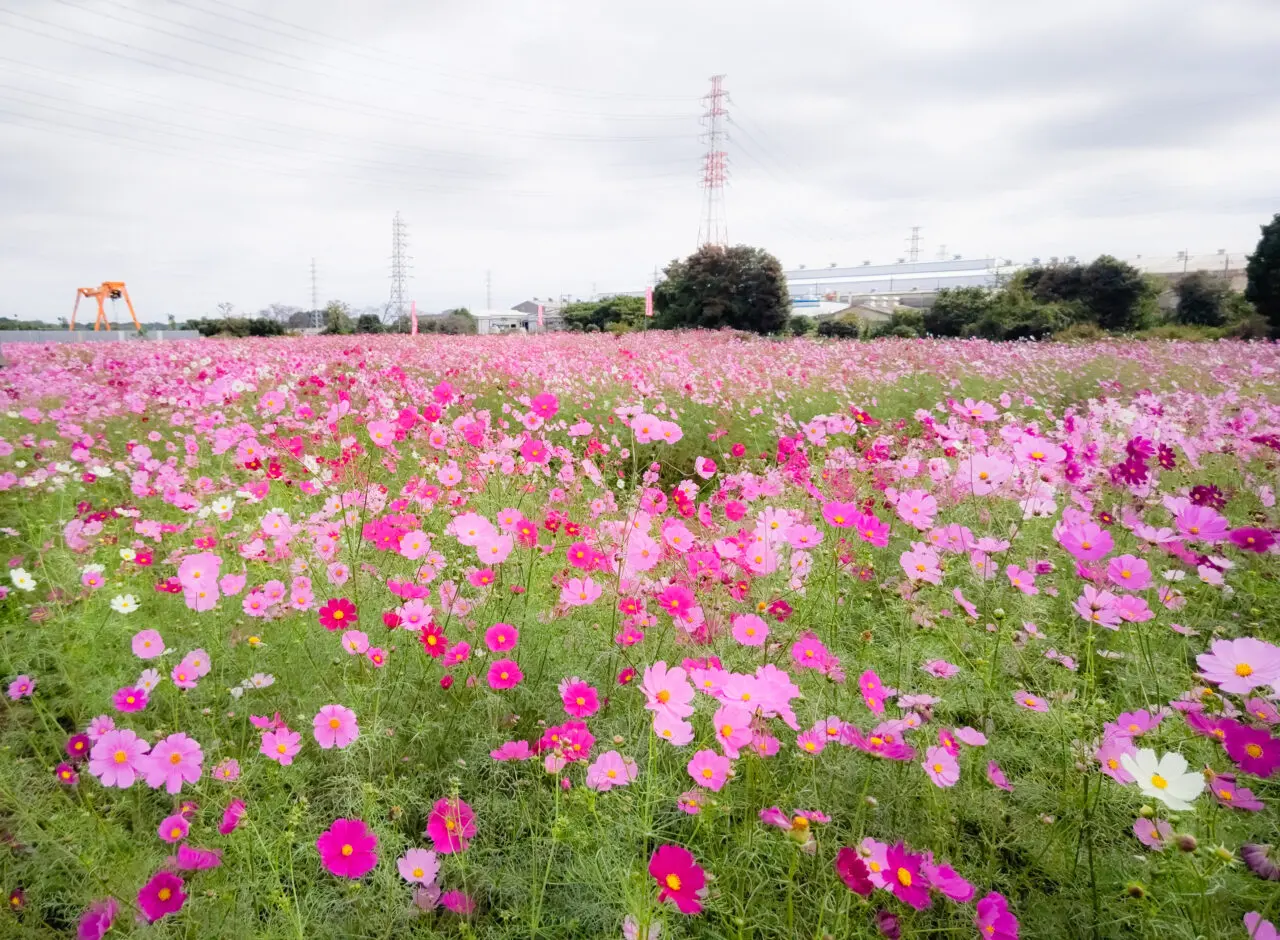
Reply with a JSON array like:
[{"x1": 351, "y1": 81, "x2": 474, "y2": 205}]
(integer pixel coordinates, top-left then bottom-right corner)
[{"x1": 0, "y1": 0, "x2": 1280, "y2": 320}]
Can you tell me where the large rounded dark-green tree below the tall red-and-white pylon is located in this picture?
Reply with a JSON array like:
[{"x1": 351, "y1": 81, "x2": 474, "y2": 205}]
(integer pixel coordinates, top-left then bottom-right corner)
[{"x1": 653, "y1": 245, "x2": 791, "y2": 333}]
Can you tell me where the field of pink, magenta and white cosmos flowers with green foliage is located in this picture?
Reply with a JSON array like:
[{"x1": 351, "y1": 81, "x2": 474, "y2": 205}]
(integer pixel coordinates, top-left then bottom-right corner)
[{"x1": 0, "y1": 332, "x2": 1280, "y2": 940}]
